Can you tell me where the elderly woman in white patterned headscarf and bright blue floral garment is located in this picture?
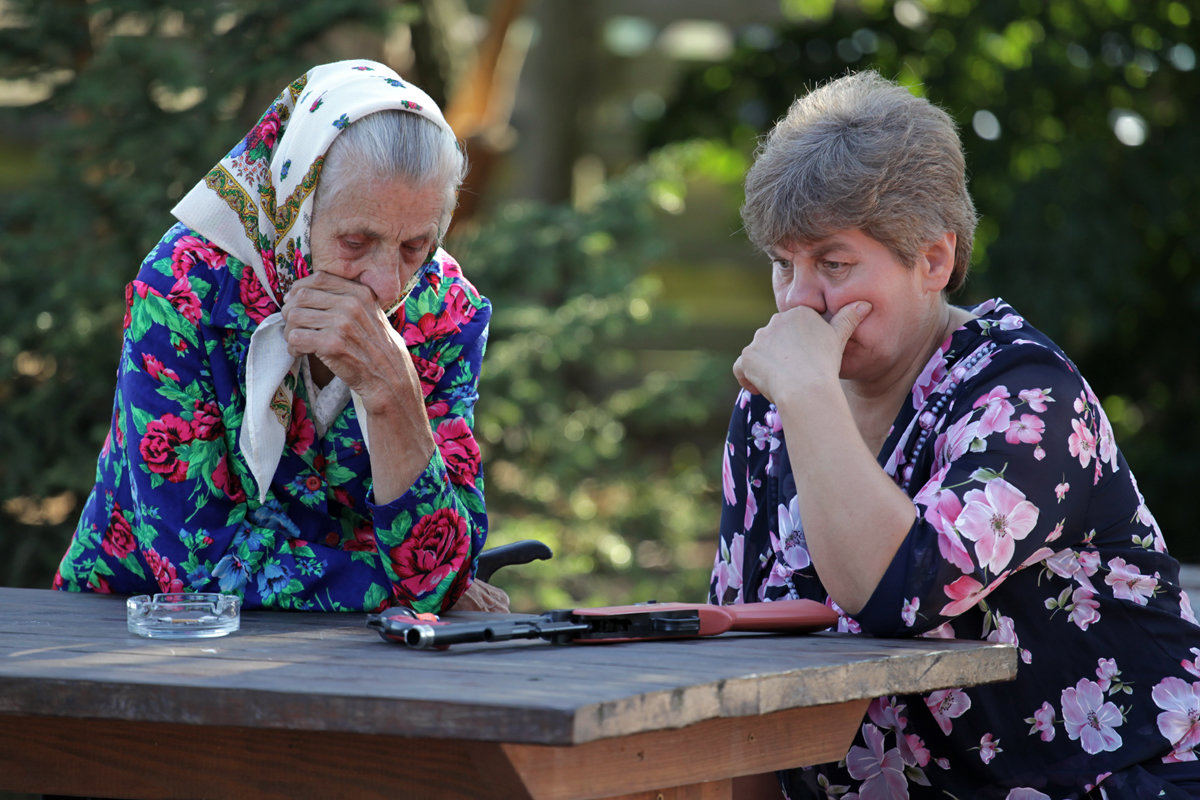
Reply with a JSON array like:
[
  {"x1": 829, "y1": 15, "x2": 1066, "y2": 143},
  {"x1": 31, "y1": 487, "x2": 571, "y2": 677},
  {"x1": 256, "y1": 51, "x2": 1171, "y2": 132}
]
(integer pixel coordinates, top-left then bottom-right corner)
[{"x1": 54, "y1": 61, "x2": 506, "y2": 612}]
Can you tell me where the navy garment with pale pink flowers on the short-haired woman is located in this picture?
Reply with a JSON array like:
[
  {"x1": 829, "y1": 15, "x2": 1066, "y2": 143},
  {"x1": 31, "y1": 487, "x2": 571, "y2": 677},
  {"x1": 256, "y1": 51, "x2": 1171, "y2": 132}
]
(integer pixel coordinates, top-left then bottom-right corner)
[{"x1": 710, "y1": 300, "x2": 1200, "y2": 800}]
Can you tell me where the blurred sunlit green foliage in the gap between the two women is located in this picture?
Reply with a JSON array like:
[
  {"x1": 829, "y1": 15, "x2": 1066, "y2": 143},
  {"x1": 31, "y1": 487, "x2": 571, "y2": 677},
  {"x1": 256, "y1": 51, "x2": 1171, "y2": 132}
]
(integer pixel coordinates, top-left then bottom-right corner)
[{"x1": 455, "y1": 148, "x2": 732, "y2": 609}]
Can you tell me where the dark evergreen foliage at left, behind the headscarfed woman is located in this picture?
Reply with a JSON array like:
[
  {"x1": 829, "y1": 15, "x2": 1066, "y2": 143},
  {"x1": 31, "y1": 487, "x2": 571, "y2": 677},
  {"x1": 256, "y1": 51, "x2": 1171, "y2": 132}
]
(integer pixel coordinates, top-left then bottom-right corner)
[{"x1": 0, "y1": 0, "x2": 419, "y2": 585}]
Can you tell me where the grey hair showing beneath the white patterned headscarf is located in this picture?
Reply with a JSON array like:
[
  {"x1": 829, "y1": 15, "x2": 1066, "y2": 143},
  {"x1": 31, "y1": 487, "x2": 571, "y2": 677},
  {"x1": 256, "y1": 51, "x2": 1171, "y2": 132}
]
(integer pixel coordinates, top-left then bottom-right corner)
[{"x1": 313, "y1": 110, "x2": 467, "y2": 239}]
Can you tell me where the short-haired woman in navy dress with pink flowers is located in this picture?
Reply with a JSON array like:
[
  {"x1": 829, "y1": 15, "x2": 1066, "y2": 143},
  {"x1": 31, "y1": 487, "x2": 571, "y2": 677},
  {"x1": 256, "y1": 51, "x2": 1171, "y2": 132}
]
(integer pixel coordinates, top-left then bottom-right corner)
[{"x1": 710, "y1": 72, "x2": 1200, "y2": 800}]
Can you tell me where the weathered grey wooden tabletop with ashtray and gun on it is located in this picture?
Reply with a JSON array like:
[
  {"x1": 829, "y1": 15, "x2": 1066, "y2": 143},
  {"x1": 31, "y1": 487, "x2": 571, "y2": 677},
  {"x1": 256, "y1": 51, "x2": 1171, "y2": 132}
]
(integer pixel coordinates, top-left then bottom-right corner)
[{"x1": 0, "y1": 589, "x2": 1016, "y2": 745}]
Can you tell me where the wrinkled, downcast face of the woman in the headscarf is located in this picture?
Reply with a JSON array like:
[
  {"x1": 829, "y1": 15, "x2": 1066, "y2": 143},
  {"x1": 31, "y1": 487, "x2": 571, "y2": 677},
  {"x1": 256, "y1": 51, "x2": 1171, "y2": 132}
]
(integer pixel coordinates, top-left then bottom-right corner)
[{"x1": 310, "y1": 175, "x2": 445, "y2": 308}]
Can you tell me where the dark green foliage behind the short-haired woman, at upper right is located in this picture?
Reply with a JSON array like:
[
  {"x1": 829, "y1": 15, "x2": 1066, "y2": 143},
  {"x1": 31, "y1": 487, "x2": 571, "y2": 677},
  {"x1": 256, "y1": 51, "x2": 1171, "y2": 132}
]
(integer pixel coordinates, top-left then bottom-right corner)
[{"x1": 646, "y1": 0, "x2": 1200, "y2": 561}]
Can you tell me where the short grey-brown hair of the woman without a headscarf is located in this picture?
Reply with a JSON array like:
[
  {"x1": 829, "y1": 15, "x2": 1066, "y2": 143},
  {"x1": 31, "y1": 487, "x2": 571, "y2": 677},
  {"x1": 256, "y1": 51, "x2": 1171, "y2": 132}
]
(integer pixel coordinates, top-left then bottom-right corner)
[{"x1": 742, "y1": 71, "x2": 977, "y2": 293}]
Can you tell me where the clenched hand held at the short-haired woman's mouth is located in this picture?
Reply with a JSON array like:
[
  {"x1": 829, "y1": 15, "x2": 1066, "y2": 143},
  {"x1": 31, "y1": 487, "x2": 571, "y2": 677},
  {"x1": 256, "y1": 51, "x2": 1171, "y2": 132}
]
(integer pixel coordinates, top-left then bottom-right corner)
[{"x1": 733, "y1": 301, "x2": 871, "y2": 403}]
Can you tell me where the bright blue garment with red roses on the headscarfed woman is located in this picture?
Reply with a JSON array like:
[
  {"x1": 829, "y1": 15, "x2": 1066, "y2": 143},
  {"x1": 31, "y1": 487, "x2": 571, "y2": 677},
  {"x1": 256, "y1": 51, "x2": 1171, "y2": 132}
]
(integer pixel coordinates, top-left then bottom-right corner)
[{"x1": 54, "y1": 224, "x2": 491, "y2": 612}]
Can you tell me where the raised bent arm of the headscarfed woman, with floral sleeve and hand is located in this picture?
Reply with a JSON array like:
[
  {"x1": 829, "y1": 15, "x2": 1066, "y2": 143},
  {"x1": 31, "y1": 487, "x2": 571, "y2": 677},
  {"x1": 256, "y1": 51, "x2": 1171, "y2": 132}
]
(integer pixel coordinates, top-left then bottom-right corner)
[{"x1": 276, "y1": 254, "x2": 491, "y2": 610}]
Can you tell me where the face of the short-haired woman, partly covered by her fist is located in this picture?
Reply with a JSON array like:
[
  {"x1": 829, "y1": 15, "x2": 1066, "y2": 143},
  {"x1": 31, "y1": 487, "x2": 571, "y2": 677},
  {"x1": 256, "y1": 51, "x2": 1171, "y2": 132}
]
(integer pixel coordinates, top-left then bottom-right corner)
[{"x1": 769, "y1": 229, "x2": 946, "y2": 381}]
